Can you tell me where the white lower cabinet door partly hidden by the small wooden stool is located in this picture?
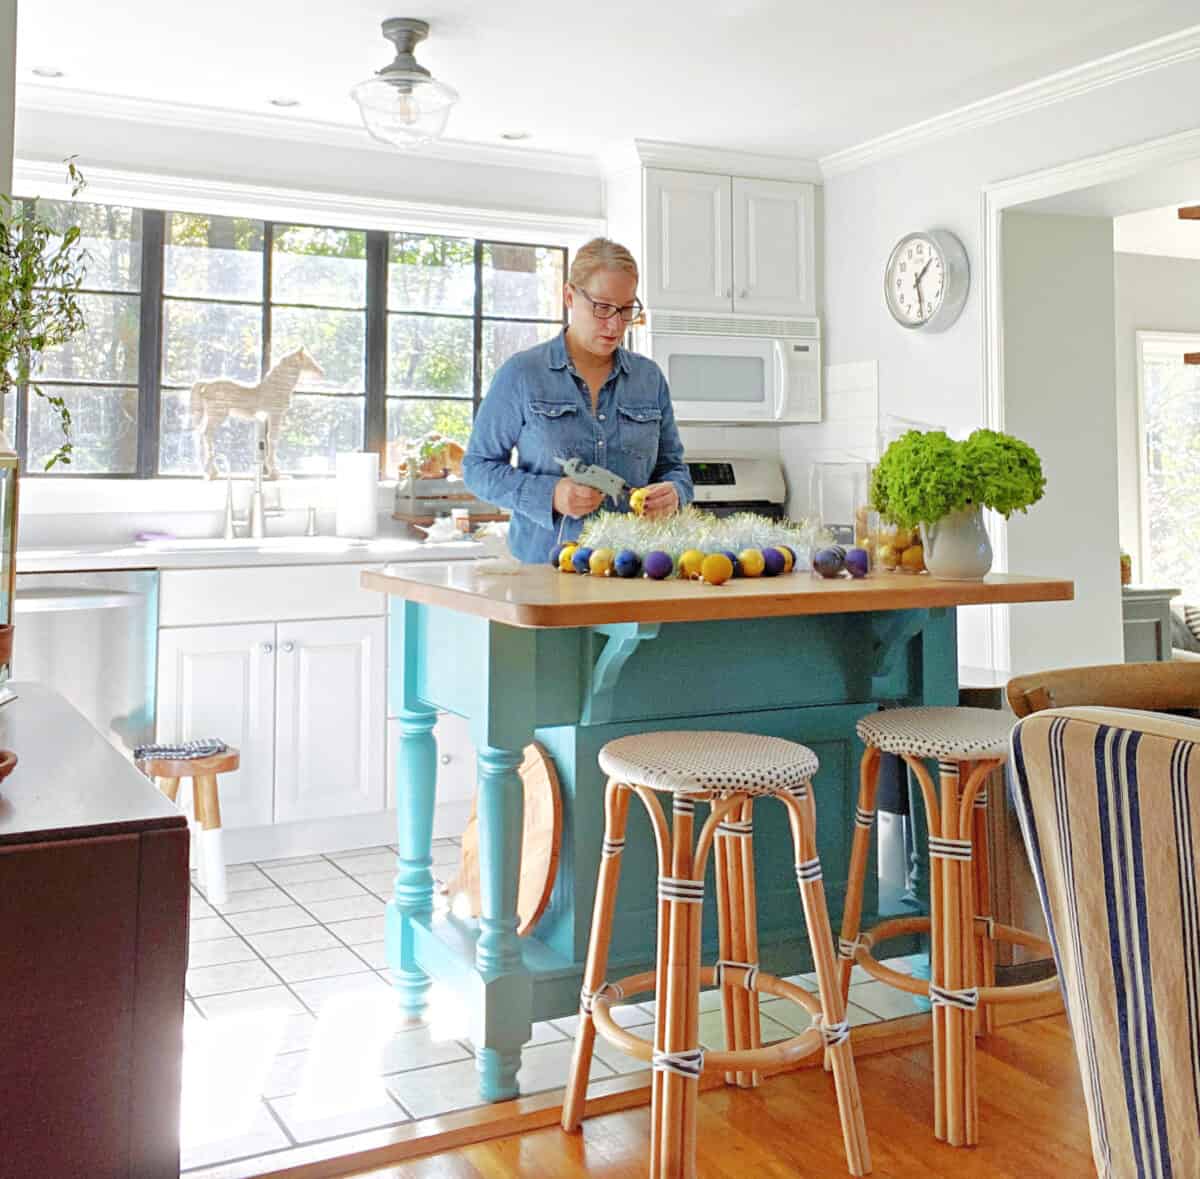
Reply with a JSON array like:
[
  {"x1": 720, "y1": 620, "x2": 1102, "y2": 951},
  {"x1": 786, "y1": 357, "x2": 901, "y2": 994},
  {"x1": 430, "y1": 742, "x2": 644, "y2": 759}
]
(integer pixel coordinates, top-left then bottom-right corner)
[{"x1": 157, "y1": 623, "x2": 275, "y2": 827}]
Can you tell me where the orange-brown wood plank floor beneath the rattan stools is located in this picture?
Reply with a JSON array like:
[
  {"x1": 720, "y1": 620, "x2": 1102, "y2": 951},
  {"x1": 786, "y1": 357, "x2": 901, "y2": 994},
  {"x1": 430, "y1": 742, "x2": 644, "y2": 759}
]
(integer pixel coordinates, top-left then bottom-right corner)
[{"x1": 350, "y1": 1016, "x2": 1096, "y2": 1179}]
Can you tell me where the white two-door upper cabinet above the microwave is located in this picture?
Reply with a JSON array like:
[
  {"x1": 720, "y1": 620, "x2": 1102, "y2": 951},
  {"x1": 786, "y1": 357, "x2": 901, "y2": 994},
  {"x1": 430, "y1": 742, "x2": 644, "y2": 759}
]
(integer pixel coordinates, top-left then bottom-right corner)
[{"x1": 638, "y1": 168, "x2": 816, "y2": 316}]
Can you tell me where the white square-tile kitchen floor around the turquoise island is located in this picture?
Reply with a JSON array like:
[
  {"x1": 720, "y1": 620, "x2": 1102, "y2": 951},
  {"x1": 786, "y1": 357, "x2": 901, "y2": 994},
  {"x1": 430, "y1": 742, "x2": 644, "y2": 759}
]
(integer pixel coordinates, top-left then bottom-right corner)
[{"x1": 182, "y1": 840, "x2": 916, "y2": 1172}]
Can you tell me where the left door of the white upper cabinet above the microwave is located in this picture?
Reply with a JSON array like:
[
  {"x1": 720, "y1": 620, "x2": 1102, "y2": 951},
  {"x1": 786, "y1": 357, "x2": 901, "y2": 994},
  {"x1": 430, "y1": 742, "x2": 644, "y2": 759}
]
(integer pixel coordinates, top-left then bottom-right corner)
[{"x1": 646, "y1": 168, "x2": 732, "y2": 311}]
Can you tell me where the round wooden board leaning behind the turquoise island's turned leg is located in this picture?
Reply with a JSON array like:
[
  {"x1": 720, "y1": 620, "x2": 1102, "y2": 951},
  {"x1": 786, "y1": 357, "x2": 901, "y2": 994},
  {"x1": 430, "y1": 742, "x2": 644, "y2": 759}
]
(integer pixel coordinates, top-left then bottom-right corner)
[{"x1": 450, "y1": 741, "x2": 563, "y2": 935}]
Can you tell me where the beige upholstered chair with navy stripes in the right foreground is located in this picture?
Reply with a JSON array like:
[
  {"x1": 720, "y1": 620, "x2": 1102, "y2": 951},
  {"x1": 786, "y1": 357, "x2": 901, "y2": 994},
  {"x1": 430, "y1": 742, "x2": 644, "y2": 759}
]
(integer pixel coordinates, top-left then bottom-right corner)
[{"x1": 1009, "y1": 707, "x2": 1200, "y2": 1179}]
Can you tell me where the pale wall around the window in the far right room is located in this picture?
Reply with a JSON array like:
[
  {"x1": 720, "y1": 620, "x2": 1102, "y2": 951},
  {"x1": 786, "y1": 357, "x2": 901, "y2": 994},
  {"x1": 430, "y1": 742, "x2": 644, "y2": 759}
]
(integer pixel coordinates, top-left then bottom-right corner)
[{"x1": 1115, "y1": 249, "x2": 1200, "y2": 571}]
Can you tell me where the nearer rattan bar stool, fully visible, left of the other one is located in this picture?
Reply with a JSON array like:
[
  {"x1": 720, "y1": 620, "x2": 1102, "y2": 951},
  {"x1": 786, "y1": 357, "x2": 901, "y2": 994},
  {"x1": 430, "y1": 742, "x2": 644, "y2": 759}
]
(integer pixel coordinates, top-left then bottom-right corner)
[{"x1": 563, "y1": 732, "x2": 871, "y2": 1179}]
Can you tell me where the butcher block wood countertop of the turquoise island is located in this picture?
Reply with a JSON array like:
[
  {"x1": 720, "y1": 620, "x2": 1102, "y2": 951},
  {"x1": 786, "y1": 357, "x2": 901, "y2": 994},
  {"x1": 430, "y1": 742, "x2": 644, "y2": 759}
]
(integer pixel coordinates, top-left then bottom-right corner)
[{"x1": 362, "y1": 562, "x2": 1075, "y2": 627}]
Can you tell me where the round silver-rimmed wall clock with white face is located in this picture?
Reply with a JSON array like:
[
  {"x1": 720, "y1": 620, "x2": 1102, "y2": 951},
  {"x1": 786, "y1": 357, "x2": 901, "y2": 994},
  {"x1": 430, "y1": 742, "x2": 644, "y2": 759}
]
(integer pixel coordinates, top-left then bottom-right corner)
[{"x1": 883, "y1": 229, "x2": 971, "y2": 331}]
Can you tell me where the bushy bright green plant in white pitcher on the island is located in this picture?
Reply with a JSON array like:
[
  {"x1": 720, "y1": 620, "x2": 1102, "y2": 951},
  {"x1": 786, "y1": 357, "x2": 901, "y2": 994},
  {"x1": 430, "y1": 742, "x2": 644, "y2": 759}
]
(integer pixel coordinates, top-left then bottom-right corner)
[{"x1": 871, "y1": 430, "x2": 1045, "y2": 581}]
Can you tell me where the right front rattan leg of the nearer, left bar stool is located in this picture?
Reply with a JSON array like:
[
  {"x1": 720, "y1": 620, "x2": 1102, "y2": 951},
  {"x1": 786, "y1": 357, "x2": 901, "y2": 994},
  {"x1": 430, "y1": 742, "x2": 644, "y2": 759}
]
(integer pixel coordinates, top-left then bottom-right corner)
[{"x1": 779, "y1": 788, "x2": 871, "y2": 1175}]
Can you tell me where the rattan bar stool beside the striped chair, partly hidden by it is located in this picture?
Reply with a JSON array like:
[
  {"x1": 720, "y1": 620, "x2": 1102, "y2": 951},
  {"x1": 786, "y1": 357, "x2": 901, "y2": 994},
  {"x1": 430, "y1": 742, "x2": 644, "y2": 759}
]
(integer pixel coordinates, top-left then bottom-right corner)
[{"x1": 838, "y1": 708, "x2": 1058, "y2": 1147}]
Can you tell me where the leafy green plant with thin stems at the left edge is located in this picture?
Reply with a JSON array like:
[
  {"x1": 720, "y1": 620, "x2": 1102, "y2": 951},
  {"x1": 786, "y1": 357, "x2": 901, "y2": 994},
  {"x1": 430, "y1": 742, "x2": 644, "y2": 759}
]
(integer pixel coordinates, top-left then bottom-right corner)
[{"x1": 0, "y1": 160, "x2": 88, "y2": 469}]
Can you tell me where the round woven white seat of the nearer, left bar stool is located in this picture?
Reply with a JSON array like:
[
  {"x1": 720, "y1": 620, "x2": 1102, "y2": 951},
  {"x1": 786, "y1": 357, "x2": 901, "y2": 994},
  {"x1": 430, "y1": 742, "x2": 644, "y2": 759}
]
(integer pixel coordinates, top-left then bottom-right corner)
[{"x1": 600, "y1": 730, "x2": 820, "y2": 798}]
